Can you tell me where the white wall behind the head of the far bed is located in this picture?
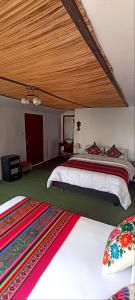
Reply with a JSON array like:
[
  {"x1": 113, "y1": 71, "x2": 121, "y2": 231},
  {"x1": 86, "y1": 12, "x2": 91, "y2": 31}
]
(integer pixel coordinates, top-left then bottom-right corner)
[{"x1": 74, "y1": 107, "x2": 135, "y2": 160}]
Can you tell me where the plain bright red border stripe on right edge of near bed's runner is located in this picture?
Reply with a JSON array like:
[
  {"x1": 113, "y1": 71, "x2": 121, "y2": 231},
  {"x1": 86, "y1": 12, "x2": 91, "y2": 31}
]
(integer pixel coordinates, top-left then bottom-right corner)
[{"x1": 12, "y1": 215, "x2": 80, "y2": 300}]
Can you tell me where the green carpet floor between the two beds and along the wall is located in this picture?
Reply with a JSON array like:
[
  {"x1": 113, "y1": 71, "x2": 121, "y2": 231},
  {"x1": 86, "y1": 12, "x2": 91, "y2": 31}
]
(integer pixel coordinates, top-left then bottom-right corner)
[{"x1": 0, "y1": 159, "x2": 135, "y2": 225}]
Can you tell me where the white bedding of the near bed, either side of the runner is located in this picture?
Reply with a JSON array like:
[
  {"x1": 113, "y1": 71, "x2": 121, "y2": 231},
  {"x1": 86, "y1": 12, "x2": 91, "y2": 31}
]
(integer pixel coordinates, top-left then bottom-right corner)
[{"x1": 0, "y1": 196, "x2": 132, "y2": 300}]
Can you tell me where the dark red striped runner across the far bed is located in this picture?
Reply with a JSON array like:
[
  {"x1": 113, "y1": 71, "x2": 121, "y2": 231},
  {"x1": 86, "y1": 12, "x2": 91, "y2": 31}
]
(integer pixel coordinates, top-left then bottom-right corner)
[{"x1": 61, "y1": 159, "x2": 129, "y2": 184}]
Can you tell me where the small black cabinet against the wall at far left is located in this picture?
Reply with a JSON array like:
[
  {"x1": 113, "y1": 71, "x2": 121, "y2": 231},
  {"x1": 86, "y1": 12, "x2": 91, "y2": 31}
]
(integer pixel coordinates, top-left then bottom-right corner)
[{"x1": 1, "y1": 154, "x2": 21, "y2": 181}]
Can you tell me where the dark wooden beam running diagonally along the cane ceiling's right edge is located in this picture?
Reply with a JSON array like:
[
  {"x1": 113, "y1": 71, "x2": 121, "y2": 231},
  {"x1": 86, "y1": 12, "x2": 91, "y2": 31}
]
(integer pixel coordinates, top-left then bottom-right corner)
[{"x1": 61, "y1": 0, "x2": 128, "y2": 106}]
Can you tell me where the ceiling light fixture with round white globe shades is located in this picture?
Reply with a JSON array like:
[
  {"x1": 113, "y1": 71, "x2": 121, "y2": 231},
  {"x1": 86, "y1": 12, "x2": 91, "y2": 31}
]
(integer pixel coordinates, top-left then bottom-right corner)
[{"x1": 21, "y1": 86, "x2": 41, "y2": 105}]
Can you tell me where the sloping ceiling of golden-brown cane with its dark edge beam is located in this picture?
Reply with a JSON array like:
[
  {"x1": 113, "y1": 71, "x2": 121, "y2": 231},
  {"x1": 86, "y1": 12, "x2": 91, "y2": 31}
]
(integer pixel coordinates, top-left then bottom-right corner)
[{"x1": 0, "y1": 0, "x2": 127, "y2": 109}]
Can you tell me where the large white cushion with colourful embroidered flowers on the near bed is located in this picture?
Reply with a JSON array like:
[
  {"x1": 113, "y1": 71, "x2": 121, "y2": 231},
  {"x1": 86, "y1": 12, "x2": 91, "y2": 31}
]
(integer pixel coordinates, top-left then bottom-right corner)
[{"x1": 103, "y1": 215, "x2": 135, "y2": 274}]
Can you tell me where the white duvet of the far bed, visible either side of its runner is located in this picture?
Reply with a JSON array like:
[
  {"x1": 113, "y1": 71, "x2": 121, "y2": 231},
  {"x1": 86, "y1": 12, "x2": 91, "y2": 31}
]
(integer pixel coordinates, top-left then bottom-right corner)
[{"x1": 47, "y1": 153, "x2": 135, "y2": 209}]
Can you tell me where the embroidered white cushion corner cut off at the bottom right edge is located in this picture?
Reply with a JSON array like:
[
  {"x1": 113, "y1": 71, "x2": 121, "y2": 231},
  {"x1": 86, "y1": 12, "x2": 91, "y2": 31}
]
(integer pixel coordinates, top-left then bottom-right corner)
[{"x1": 109, "y1": 284, "x2": 135, "y2": 300}]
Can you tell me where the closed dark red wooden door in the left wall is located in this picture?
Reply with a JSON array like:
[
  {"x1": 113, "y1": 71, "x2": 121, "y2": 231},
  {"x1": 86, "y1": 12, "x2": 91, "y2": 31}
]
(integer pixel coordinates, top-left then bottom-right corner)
[{"x1": 25, "y1": 113, "x2": 43, "y2": 165}]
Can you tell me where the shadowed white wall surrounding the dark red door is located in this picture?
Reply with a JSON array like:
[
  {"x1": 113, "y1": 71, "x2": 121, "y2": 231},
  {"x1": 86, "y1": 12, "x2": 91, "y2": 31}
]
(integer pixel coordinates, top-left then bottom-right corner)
[{"x1": 0, "y1": 99, "x2": 60, "y2": 179}]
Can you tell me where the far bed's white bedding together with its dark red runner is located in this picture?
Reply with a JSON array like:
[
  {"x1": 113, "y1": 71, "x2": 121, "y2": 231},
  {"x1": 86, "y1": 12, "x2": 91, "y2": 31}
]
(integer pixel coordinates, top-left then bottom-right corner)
[{"x1": 47, "y1": 153, "x2": 135, "y2": 209}]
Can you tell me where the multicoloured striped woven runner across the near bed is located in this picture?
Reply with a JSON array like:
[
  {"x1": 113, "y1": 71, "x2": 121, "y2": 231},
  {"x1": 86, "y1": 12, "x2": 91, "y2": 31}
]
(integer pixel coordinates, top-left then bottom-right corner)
[{"x1": 0, "y1": 197, "x2": 80, "y2": 300}]
